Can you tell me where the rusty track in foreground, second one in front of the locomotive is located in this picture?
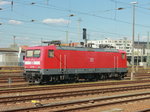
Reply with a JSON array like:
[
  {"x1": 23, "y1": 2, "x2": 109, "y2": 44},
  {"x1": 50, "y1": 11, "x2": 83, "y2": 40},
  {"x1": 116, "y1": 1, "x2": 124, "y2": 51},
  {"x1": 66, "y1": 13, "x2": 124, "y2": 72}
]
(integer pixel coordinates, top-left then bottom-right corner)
[{"x1": 0, "y1": 84, "x2": 150, "y2": 104}]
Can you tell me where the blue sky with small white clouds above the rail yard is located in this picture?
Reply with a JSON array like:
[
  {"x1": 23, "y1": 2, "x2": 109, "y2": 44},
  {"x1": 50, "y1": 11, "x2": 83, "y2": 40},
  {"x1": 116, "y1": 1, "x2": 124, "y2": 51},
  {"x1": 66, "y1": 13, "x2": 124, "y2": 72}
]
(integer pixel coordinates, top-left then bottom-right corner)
[{"x1": 0, "y1": 0, "x2": 150, "y2": 48}]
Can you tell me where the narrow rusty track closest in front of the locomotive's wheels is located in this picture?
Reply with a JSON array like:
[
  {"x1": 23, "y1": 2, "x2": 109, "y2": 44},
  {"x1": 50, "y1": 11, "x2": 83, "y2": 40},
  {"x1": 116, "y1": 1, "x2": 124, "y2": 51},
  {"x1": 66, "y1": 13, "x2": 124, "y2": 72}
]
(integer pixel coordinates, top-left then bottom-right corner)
[{"x1": 0, "y1": 80, "x2": 150, "y2": 94}]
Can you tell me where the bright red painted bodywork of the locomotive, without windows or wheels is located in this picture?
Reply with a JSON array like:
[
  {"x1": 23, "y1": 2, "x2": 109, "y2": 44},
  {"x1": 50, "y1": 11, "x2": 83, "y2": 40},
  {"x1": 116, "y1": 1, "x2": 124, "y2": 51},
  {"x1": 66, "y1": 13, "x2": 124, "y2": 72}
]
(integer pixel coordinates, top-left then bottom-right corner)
[{"x1": 25, "y1": 46, "x2": 127, "y2": 69}]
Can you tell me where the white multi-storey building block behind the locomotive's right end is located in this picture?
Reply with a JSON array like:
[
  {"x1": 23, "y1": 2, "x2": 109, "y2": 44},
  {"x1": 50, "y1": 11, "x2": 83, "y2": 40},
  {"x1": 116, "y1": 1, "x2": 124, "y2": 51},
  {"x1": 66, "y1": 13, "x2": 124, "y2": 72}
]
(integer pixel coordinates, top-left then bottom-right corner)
[{"x1": 87, "y1": 38, "x2": 149, "y2": 65}]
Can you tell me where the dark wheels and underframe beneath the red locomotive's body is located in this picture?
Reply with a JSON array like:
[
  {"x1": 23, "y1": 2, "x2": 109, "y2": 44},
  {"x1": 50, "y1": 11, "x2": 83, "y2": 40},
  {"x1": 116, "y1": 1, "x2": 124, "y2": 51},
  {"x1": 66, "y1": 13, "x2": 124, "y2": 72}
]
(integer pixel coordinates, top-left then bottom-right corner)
[{"x1": 24, "y1": 71, "x2": 126, "y2": 84}]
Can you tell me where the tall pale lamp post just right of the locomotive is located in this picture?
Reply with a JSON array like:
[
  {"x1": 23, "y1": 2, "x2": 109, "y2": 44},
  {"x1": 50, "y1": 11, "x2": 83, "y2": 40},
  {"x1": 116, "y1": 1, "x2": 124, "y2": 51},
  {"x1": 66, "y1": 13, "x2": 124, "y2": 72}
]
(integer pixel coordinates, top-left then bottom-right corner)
[{"x1": 131, "y1": 2, "x2": 137, "y2": 80}]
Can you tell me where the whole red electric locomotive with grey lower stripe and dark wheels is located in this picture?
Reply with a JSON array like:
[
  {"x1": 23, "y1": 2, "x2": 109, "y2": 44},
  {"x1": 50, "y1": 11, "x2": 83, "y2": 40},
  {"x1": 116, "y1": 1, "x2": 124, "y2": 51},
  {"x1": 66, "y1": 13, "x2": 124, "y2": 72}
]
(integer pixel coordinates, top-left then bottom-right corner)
[{"x1": 24, "y1": 45, "x2": 127, "y2": 83}]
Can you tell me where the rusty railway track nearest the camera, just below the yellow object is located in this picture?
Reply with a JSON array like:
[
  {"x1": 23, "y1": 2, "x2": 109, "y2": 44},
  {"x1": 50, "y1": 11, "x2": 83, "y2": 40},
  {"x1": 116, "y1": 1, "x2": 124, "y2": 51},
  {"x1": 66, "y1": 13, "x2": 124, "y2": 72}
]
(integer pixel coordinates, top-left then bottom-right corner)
[{"x1": 5, "y1": 92, "x2": 150, "y2": 112}]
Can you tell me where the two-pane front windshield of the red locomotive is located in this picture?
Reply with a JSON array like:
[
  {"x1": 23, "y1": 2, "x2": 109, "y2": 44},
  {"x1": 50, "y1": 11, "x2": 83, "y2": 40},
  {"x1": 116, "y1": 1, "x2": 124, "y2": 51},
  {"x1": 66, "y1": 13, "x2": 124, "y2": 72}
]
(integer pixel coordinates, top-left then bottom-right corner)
[{"x1": 26, "y1": 49, "x2": 41, "y2": 58}]
